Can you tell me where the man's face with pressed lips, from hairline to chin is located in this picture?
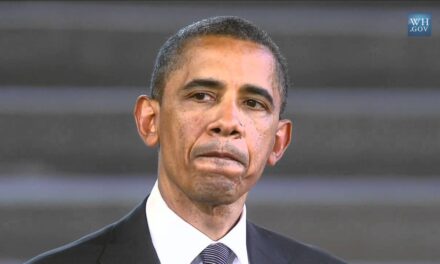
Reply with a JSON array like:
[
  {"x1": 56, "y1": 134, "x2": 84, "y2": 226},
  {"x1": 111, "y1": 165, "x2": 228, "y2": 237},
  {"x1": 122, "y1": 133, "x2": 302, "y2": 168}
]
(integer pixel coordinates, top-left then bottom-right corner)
[{"x1": 143, "y1": 36, "x2": 290, "y2": 205}]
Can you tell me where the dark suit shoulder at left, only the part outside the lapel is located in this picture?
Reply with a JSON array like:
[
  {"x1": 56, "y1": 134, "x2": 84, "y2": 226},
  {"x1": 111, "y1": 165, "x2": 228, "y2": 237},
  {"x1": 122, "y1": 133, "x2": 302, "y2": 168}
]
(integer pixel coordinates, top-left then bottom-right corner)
[{"x1": 25, "y1": 225, "x2": 114, "y2": 264}]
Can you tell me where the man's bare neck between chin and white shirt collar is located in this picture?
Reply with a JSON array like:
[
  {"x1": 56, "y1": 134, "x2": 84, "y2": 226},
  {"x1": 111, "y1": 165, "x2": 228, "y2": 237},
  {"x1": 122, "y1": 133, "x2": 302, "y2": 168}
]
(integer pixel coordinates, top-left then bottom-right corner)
[{"x1": 159, "y1": 178, "x2": 246, "y2": 241}]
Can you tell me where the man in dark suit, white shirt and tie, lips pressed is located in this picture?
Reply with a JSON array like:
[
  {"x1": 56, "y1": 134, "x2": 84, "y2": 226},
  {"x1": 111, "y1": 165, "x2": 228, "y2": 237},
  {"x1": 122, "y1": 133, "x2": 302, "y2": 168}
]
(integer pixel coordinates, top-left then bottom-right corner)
[{"x1": 25, "y1": 17, "x2": 343, "y2": 264}]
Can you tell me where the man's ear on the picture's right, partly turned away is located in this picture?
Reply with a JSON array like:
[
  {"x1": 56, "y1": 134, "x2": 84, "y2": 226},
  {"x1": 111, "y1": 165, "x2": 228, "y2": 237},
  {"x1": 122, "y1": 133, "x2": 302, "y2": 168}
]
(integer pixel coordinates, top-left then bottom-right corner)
[{"x1": 267, "y1": 119, "x2": 293, "y2": 166}]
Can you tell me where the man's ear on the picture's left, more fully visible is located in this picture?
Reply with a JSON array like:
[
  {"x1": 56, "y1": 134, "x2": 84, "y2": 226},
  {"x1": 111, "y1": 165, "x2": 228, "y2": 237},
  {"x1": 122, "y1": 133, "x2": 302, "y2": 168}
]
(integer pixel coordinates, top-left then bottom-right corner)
[{"x1": 133, "y1": 95, "x2": 160, "y2": 147}]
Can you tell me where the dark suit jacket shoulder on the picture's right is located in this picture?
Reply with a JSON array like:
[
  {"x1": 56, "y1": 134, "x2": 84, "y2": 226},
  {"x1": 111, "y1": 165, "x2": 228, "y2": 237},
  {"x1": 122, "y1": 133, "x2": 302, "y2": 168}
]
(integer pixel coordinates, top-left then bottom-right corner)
[{"x1": 248, "y1": 222, "x2": 346, "y2": 264}]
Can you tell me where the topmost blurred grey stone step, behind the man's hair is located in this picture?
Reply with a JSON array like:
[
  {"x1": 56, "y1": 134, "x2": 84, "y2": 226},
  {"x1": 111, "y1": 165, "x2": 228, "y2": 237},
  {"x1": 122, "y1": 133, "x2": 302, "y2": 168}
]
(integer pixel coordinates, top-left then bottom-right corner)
[{"x1": 0, "y1": 2, "x2": 440, "y2": 89}]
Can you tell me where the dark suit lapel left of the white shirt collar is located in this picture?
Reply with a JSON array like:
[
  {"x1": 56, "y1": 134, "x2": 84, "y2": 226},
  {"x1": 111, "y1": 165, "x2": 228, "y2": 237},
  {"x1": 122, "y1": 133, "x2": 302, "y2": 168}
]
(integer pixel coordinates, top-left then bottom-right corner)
[{"x1": 100, "y1": 198, "x2": 159, "y2": 264}]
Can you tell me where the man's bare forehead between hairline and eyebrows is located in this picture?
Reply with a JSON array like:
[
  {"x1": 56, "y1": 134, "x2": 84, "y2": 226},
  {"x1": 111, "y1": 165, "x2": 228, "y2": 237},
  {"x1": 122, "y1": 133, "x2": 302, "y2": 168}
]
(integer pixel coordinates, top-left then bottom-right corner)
[{"x1": 179, "y1": 36, "x2": 279, "y2": 95}]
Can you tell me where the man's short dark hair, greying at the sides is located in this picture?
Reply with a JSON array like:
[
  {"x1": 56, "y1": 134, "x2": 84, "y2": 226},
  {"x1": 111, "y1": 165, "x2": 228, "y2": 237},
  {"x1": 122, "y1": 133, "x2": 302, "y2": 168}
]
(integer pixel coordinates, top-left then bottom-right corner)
[{"x1": 150, "y1": 16, "x2": 290, "y2": 114}]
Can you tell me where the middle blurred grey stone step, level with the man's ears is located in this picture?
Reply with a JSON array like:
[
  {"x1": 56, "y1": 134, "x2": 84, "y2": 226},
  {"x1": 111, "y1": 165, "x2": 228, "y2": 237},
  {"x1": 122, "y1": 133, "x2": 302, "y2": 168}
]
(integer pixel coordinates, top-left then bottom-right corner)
[{"x1": 0, "y1": 87, "x2": 440, "y2": 177}]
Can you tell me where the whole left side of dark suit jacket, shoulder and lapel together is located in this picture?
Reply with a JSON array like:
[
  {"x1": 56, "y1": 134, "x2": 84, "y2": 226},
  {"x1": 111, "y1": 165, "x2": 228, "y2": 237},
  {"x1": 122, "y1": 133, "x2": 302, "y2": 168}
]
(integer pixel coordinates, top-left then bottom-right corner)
[{"x1": 26, "y1": 199, "x2": 158, "y2": 264}]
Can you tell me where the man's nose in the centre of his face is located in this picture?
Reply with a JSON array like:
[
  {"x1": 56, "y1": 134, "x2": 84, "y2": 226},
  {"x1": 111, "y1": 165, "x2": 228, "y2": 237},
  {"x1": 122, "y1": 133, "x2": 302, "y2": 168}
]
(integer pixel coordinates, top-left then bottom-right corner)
[{"x1": 208, "y1": 98, "x2": 245, "y2": 139}]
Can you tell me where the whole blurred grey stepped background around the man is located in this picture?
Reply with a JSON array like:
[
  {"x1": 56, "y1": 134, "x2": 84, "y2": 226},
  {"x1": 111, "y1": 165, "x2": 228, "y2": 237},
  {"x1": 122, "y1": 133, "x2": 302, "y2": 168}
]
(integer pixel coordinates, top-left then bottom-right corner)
[{"x1": 0, "y1": 1, "x2": 440, "y2": 264}]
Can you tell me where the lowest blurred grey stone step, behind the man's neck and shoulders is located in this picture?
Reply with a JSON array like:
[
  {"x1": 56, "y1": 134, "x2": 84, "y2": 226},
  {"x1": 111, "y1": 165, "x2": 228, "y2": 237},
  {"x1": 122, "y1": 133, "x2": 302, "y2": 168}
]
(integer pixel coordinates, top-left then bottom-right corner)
[{"x1": 0, "y1": 175, "x2": 440, "y2": 263}]
